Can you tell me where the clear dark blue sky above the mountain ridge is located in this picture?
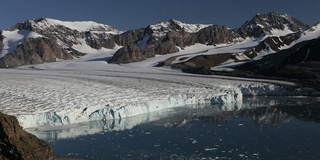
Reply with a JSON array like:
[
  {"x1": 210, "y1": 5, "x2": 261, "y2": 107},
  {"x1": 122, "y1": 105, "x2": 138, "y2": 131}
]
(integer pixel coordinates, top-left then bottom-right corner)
[{"x1": 0, "y1": 0, "x2": 320, "y2": 30}]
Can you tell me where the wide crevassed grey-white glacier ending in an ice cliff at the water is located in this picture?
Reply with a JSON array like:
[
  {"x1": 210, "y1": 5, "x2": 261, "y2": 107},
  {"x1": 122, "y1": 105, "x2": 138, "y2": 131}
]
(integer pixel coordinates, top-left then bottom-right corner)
[{"x1": 0, "y1": 67, "x2": 312, "y2": 128}]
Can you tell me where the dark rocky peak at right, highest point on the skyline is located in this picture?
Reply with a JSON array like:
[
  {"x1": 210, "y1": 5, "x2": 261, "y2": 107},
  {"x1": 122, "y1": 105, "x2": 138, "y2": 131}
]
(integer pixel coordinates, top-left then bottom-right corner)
[{"x1": 240, "y1": 12, "x2": 309, "y2": 37}]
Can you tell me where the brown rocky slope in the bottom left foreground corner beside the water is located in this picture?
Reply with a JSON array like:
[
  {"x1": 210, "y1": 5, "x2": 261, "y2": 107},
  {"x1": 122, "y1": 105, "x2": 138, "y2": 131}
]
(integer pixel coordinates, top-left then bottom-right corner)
[{"x1": 0, "y1": 113, "x2": 57, "y2": 160}]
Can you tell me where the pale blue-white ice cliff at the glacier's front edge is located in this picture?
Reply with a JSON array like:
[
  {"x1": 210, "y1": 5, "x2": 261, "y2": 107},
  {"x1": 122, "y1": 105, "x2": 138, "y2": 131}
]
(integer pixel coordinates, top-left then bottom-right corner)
[{"x1": 17, "y1": 91, "x2": 242, "y2": 128}]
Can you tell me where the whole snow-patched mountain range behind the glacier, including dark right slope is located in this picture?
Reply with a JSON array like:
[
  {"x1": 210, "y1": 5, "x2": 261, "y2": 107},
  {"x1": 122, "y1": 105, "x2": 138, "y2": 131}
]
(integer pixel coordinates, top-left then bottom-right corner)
[{"x1": 0, "y1": 12, "x2": 320, "y2": 88}]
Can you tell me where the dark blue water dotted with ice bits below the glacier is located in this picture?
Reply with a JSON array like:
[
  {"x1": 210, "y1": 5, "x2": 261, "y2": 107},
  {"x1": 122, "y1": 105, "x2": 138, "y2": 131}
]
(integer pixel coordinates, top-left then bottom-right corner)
[{"x1": 30, "y1": 99, "x2": 320, "y2": 160}]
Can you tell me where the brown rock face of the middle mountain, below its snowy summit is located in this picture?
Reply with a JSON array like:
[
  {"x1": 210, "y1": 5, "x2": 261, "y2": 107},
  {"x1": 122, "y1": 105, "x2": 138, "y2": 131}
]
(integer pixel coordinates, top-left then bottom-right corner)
[{"x1": 110, "y1": 24, "x2": 237, "y2": 63}]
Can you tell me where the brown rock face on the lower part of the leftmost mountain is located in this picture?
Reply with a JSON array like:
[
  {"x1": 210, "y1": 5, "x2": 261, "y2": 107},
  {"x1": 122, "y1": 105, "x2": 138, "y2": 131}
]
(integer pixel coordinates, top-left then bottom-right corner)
[{"x1": 0, "y1": 38, "x2": 72, "y2": 68}]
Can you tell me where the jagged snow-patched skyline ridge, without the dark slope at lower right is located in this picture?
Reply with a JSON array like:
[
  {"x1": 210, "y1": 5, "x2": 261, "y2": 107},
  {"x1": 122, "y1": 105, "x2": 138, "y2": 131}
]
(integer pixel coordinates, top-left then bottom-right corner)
[{"x1": 0, "y1": 12, "x2": 309, "y2": 67}]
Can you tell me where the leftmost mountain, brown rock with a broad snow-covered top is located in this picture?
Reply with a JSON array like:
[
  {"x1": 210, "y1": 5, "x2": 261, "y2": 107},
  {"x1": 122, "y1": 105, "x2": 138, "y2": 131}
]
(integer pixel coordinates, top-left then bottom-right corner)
[{"x1": 0, "y1": 18, "x2": 121, "y2": 67}]
